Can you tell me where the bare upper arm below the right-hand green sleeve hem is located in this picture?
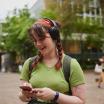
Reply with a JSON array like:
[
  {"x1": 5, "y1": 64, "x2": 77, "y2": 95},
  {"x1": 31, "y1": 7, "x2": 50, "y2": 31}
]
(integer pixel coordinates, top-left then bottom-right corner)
[{"x1": 72, "y1": 84, "x2": 86, "y2": 103}]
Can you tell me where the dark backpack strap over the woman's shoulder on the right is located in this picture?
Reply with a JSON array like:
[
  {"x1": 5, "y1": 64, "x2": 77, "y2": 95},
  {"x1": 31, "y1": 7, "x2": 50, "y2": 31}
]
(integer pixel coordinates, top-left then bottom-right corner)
[{"x1": 63, "y1": 55, "x2": 72, "y2": 95}]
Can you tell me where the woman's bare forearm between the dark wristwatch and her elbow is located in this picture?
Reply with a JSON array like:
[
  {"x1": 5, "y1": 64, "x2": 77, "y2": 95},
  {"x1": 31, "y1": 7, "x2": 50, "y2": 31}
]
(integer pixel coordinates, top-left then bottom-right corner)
[{"x1": 57, "y1": 93, "x2": 85, "y2": 104}]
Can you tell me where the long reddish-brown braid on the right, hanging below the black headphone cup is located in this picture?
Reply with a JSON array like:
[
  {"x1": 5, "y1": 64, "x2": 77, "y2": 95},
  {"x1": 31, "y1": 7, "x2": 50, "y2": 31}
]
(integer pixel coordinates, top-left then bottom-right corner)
[{"x1": 55, "y1": 38, "x2": 63, "y2": 70}]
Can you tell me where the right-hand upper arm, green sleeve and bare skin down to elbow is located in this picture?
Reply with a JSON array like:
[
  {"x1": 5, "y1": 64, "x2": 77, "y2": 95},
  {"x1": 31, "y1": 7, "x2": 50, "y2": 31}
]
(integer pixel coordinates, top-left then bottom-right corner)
[{"x1": 70, "y1": 59, "x2": 86, "y2": 103}]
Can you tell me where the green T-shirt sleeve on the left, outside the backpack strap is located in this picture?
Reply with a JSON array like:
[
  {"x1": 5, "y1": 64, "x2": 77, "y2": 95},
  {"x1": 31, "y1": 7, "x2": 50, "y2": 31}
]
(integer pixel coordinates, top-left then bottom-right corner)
[{"x1": 20, "y1": 58, "x2": 30, "y2": 81}]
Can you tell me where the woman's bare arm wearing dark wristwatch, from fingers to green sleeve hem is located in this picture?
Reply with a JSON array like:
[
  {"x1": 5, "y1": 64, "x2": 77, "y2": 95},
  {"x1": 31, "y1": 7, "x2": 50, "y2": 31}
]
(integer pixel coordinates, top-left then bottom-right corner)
[{"x1": 33, "y1": 85, "x2": 85, "y2": 104}]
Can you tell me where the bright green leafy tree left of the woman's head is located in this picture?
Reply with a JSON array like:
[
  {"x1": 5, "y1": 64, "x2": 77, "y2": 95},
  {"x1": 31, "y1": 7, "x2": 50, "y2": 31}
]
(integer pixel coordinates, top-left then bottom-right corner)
[{"x1": 2, "y1": 7, "x2": 35, "y2": 58}]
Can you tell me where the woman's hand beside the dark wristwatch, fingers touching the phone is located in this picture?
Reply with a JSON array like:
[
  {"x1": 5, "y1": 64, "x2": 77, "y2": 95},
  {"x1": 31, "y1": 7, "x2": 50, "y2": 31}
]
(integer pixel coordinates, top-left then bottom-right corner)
[{"x1": 33, "y1": 87, "x2": 56, "y2": 100}]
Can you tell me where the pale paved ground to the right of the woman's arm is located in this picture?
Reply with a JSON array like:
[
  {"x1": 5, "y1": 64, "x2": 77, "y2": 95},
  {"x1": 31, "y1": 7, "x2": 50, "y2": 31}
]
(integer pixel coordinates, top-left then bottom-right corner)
[{"x1": 85, "y1": 72, "x2": 104, "y2": 104}]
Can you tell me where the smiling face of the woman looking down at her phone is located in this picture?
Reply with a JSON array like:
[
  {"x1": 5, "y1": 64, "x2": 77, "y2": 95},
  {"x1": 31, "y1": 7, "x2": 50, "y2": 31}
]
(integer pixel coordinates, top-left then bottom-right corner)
[{"x1": 33, "y1": 29, "x2": 56, "y2": 56}]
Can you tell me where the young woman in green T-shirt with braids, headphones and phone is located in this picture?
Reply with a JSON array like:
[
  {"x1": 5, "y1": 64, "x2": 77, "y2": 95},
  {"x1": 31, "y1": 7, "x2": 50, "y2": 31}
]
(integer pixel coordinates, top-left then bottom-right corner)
[{"x1": 19, "y1": 18, "x2": 85, "y2": 104}]
